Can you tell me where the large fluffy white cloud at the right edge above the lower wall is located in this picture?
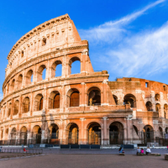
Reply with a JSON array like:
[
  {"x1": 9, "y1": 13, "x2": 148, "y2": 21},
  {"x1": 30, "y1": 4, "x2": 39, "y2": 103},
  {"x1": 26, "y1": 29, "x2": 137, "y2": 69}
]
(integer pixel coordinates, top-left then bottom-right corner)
[{"x1": 101, "y1": 23, "x2": 168, "y2": 76}]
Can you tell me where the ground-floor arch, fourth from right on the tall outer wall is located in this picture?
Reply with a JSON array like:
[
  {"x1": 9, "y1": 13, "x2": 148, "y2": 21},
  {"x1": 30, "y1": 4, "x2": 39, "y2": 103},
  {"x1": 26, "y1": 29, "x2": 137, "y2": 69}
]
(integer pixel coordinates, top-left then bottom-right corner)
[{"x1": 49, "y1": 124, "x2": 59, "y2": 140}]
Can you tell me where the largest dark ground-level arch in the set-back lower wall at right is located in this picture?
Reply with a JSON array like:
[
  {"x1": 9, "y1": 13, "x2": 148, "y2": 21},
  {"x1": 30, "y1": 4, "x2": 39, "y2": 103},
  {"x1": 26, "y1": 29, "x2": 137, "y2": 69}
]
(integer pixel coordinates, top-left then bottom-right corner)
[{"x1": 143, "y1": 125, "x2": 154, "y2": 144}]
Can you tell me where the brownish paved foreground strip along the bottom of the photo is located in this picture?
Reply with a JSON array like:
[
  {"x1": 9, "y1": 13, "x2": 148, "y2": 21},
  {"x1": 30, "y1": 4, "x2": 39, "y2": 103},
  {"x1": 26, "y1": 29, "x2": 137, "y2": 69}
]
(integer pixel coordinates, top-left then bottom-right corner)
[{"x1": 0, "y1": 154, "x2": 168, "y2": 168}]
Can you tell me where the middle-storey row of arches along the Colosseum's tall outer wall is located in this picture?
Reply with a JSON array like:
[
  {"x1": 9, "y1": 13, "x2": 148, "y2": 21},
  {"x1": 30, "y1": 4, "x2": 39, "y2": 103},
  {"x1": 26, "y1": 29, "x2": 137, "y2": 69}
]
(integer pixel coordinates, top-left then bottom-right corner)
[{"x1": 4, "y1": 87, "x2": 101, "y2": 117}]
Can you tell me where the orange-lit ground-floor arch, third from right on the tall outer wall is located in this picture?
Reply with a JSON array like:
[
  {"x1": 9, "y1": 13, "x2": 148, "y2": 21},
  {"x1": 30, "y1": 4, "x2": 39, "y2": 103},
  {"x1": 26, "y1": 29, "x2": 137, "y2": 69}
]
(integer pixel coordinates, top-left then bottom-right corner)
[{"x1": 68, "y1": 123, "x2": 79, "y2": 144}]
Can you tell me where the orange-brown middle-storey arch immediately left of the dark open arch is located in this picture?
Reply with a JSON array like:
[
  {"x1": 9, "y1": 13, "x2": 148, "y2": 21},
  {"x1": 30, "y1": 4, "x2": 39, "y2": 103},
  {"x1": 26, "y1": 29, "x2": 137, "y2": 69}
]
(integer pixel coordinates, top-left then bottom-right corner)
[{"x1": 67, "y1": 88, "x2": 80, "y2": 107}]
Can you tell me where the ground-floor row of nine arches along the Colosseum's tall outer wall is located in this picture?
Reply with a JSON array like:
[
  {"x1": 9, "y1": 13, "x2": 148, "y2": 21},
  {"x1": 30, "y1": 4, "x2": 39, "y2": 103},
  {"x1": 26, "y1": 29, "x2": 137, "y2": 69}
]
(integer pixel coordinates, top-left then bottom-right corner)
[{"x1": 1, "y1": 121, "x2": 124, "y2": 144}]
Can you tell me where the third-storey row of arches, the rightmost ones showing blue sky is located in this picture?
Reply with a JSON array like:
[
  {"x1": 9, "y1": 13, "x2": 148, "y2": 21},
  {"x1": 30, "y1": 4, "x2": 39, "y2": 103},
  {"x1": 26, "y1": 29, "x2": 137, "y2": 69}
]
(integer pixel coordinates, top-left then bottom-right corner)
[{"x1": 4, "y1": 57, "x2": 81, "y2": 94}]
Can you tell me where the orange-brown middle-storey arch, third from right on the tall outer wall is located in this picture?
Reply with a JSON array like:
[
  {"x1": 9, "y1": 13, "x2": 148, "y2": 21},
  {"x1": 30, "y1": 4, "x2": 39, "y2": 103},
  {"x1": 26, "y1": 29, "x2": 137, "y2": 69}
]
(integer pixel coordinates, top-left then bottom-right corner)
[{"x1": 49, "y1": 91, "x2": 60, "y2": 109}]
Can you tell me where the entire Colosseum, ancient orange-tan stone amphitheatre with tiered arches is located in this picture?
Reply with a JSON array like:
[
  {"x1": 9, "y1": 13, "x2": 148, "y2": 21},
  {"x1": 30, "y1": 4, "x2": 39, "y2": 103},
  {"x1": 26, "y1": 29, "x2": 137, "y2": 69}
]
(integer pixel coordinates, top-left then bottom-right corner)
[{"x1": 0, "y1": 14, "x2": 168, "y2": 145}]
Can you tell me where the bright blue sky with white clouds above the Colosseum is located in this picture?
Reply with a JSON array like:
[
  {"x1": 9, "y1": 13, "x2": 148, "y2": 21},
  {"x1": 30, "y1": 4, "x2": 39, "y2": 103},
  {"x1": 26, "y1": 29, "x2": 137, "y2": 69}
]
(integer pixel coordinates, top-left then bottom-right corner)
[{"x1": 0, "y1": 0, "x2": 168, "y2": 99}]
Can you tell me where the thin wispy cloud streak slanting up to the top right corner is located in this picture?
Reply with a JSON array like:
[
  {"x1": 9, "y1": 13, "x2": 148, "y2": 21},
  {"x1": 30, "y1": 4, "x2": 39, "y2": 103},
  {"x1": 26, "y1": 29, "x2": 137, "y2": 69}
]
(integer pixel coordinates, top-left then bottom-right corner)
[{"x1": 79, "y1": 0, "x2": 165, "y2": 43}]
